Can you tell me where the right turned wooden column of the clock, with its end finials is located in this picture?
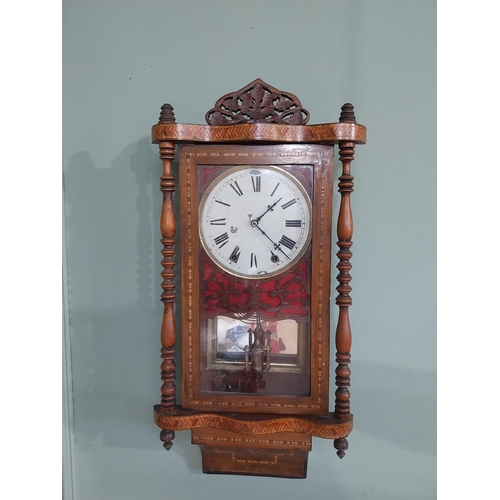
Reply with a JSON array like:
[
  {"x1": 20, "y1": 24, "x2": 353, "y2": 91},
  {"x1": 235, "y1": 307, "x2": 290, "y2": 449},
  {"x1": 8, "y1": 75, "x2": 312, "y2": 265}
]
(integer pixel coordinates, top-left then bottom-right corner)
[{"x1": 334, "y1": 104, "x2": 356, "y2": 458}]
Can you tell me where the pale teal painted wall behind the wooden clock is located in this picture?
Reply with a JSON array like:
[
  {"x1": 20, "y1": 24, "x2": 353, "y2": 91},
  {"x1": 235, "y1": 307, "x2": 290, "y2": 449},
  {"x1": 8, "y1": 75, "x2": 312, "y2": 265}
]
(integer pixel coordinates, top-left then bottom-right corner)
[{"x1": 63, "y1": 0, "x2": 436, "y2": 500}]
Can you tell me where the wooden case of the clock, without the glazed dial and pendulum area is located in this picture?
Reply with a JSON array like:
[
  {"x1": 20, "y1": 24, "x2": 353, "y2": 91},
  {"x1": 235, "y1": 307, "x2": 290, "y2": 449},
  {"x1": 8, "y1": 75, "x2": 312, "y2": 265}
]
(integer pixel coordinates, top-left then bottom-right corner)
[{"x1": 152, "y1": 80, "x2": 366, "y2": 478}]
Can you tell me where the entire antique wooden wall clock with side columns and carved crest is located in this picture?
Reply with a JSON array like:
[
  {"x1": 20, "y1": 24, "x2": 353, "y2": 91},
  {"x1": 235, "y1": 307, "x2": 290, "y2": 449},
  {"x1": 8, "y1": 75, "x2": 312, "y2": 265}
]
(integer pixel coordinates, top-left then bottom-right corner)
[{"x1": 152, "y1": 80, "x2": 366, "y2": 478}]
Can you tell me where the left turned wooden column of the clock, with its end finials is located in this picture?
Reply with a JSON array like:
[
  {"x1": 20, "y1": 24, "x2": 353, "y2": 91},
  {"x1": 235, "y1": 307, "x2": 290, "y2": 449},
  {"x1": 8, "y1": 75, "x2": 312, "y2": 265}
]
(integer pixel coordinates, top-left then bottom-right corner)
[{"x1": 159, "y1": 104, "x2": 177, "y2": 450}]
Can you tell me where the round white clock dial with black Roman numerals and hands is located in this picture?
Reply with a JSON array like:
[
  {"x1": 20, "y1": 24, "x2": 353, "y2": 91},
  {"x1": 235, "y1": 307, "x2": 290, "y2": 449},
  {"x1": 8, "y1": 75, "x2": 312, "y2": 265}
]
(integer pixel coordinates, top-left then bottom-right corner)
[{"x1": 200, "y1": 165, "x2": 312, "y2": 278}]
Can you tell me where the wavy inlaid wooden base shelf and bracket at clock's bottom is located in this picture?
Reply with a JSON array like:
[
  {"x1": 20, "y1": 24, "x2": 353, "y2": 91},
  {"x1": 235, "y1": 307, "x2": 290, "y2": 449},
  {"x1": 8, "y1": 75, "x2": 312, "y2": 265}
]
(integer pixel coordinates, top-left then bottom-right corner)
[{"x1": 154, "y1": 405, "x2": 353, "y2": 479}]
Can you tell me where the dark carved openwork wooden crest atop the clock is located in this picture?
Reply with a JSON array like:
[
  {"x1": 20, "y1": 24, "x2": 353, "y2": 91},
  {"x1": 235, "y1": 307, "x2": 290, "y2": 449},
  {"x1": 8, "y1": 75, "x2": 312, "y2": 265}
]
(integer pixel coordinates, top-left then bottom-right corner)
[{"x1": 205, "y1": 78, "x2": 309, "y2": 125}]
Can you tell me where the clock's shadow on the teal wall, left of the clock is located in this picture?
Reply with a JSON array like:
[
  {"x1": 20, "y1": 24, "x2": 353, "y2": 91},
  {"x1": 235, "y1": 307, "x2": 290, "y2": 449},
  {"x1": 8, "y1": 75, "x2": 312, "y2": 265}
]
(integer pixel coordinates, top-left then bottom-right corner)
[{"x1": 64, "y1": 137, "x2": 170, "y2": 454}]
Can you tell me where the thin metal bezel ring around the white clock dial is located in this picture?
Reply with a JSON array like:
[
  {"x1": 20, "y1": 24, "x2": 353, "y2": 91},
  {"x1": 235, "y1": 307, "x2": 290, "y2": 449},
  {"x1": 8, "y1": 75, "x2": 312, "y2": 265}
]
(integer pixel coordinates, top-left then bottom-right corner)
[{"x1": 198, "y1": 163, "x2": 314, "y2": 280}]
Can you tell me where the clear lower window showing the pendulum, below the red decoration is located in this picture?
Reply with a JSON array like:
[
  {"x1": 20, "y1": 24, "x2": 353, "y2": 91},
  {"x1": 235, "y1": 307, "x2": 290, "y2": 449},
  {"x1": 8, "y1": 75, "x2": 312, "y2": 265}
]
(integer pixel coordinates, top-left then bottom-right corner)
[{"x1": 201, "y1": 315, "x2": 310, "y2": 395}]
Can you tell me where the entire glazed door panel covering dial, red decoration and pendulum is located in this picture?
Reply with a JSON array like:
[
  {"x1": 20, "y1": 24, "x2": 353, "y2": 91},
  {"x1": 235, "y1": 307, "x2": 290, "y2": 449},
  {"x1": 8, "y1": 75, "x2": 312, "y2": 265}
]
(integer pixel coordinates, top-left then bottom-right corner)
[{"x1": 197, "y1": 159, "x2": 314, "y2": 397}]
